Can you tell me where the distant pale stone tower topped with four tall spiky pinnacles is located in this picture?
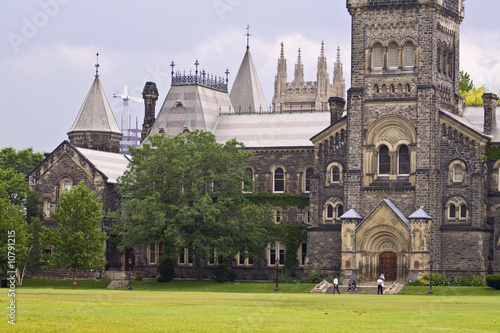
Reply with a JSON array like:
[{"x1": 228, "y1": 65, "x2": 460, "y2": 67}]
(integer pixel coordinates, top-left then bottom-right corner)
[{"x1": 272, "y1": 42, "x2": 345, "y2": 112}]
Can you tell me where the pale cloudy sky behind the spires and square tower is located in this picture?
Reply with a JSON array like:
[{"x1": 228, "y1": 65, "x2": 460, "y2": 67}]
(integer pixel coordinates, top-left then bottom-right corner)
[{"x1": 0, "y1": 0, "x2": 500, "y2": 152}]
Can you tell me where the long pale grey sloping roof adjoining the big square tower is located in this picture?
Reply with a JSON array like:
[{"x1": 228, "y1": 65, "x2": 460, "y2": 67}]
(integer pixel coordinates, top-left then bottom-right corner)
[{"x1": 214, "y1": 112, "x2": 330, "y2": 148}]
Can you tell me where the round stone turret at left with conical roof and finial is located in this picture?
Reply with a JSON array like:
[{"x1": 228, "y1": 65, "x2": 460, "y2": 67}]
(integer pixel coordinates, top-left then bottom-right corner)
[{"x1": 68, "y1": 53, "x2": 123, "y2": 153}]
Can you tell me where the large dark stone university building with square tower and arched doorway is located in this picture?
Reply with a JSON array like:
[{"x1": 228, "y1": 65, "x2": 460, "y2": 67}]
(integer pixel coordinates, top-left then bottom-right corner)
[{"x1": 29, "y1": 0, "x2": 500, "y2": 281}]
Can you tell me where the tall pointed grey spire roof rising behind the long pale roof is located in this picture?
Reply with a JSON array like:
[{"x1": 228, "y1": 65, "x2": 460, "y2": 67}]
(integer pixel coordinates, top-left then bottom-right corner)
[{"x1": 229, "y1": 48, "x2": 267, "y2": 112}]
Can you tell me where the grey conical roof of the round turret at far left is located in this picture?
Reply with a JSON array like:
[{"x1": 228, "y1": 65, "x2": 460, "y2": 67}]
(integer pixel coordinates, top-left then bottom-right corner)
[{"x1": 68, "y1": 76, "x2": 122, "y2": 134}]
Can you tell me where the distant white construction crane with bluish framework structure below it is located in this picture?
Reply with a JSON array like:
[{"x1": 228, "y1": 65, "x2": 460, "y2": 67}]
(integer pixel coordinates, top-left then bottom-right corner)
[{"x1": 113, "y1": 86, "x2": 144, "y2": 154}]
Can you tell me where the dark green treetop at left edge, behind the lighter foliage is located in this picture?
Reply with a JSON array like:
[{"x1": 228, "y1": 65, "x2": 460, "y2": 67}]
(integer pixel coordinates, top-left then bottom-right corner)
[{"x1": 0, "y1": 147, "x2": 45, "y2": 176}]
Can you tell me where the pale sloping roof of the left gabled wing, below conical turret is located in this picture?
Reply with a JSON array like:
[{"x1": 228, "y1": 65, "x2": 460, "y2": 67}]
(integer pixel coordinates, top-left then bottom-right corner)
[{"x1": 74, "y1": 147, "x2": 130, "y2": 183}]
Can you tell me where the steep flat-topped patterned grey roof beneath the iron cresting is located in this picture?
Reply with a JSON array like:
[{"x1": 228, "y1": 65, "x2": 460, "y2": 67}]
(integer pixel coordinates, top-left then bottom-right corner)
[{"x1": 150, "y1": 83, "x2": 233, "y2": 137}]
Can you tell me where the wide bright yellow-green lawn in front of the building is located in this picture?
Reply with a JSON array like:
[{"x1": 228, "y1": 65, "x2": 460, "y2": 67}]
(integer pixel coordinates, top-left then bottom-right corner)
[{"x1": 0, "y1": 280, "x2": 500, "y2": 332}]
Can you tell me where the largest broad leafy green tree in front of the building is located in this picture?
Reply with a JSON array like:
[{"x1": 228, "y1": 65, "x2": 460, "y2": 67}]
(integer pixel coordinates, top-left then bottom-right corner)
[{"x1": 115, "y1": 131, "x2": 272, "y2": 279}]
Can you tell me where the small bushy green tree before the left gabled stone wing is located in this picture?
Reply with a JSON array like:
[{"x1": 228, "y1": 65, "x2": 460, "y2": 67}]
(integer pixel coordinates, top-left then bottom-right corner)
[{"x1": 50, "y1": 181, "x2": 107, "y2": 282}]
